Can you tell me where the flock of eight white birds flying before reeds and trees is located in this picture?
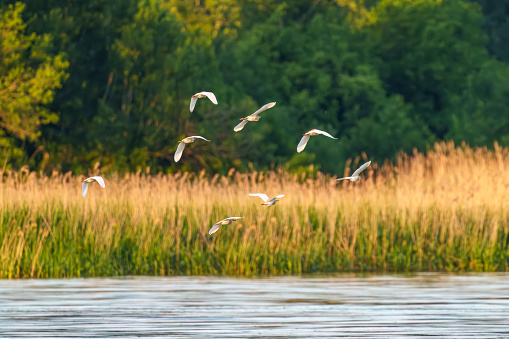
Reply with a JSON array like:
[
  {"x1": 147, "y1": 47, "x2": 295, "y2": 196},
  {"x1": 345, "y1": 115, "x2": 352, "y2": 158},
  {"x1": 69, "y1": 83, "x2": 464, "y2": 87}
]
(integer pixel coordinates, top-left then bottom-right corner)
[{"x1": 81, "y1": 92, "x2": 371, "y2": 234}]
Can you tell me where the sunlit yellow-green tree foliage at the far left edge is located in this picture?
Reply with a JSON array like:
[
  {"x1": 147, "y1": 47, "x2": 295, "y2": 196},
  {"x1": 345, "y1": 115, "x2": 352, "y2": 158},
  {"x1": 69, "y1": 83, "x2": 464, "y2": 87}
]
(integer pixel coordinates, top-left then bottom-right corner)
[{"x1": 0, "y1": 2, "x2": 69, "y2": 165}]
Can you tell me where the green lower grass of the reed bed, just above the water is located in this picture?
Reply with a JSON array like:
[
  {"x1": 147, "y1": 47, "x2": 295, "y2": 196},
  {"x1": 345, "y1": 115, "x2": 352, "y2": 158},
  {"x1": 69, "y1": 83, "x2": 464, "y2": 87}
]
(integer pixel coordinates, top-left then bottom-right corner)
[{"x1": 0, "y1": 197, "x2": 509, "y2": 278}]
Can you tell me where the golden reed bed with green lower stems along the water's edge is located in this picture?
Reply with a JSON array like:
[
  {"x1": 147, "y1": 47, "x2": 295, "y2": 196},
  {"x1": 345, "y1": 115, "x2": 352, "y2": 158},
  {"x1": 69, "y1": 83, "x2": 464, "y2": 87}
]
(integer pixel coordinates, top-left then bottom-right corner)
[{"x1": 0, "y1": 143, "x2": 509, "y2": 277}]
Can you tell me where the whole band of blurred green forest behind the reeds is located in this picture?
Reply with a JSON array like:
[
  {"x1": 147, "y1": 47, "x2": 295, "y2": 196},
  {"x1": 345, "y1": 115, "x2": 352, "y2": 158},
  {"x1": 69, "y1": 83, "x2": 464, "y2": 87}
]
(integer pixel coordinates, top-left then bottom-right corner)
[{"x1": 0, "y1": 0, "x2": 509, "y2": 174}]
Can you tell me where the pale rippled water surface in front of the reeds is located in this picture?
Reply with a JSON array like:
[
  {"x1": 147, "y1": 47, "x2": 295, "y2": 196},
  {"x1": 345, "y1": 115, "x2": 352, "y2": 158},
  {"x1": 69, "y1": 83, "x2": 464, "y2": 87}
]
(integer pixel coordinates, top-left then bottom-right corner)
[{"x1": 0, "y1": 274, "x2": 509, "y2": 338}]
